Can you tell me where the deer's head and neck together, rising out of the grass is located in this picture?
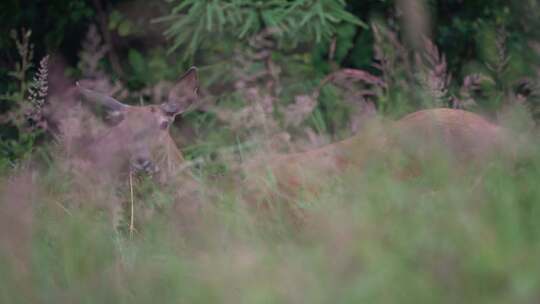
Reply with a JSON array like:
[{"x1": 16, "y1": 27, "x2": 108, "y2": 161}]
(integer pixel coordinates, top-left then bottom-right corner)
[{"x1": 63, "y1": 68, "x2": 202, "y2": 226}]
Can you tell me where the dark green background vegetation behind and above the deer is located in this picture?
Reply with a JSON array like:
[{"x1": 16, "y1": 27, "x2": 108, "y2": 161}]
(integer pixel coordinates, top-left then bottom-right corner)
[{"x1": 0, "y1": 0, "x2": 538, "y2": 169}]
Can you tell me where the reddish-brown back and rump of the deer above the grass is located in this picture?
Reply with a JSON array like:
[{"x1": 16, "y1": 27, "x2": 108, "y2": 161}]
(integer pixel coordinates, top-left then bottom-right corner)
[{"x1": 241, "y1": 108, "x2": 512, "y2": 220}]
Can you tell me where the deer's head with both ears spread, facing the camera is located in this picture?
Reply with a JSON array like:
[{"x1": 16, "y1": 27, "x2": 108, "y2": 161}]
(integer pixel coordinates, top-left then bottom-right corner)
[{"x1": 77, "y1": 68, "x2": 198, "y2": 179}]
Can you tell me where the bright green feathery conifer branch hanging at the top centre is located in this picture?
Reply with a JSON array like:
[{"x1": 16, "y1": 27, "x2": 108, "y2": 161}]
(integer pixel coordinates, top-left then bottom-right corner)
[{"x1": 159, "y1": 0, "x2": 365, "y2": 56}]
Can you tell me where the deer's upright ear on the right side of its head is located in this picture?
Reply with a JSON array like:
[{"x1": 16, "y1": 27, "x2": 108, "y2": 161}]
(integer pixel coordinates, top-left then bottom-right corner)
[{"x1": 165, "y1": 67, "x2": 199, "y2": 115}]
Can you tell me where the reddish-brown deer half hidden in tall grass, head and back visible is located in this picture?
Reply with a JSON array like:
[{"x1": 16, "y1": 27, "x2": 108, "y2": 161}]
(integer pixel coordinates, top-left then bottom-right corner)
[{"x1": 74, "y1": 68, "x2": 509, "y2": 226}]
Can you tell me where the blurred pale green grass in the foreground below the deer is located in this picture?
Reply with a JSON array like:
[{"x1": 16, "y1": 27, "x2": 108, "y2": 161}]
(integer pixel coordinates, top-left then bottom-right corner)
[{"x1": 0, "y1": 131, "x2": 540, "y2": 303}]
